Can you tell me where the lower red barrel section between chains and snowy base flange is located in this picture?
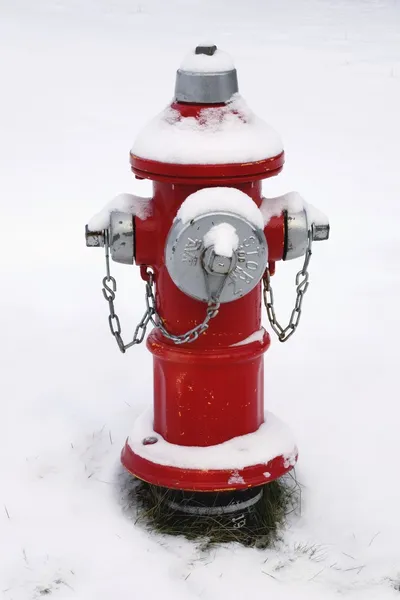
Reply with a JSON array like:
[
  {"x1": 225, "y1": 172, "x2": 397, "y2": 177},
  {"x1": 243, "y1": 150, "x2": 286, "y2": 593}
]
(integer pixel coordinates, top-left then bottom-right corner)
[{"x1": 147, "y1": 331, "x2": 270, "y2": 446}]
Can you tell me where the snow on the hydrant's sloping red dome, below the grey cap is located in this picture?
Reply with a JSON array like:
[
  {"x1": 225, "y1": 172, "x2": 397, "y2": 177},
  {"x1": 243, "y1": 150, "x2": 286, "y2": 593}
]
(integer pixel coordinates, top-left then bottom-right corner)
[{"x1": 132, "y1": 94, "x2": 283, "y2": 164}]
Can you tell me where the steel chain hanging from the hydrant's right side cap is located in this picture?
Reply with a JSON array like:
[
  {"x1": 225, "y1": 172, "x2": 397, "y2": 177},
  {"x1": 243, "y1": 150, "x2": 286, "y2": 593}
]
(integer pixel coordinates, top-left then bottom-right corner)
[{"x1": 263, "y1": 226, "x2": 313, "y2": 342}]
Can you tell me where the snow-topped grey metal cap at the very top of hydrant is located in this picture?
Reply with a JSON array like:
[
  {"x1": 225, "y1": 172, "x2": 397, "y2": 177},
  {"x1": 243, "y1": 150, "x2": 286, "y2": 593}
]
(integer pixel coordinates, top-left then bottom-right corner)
[{"x1": 175, "y1": 44, "x2": 239, "y2": 104}]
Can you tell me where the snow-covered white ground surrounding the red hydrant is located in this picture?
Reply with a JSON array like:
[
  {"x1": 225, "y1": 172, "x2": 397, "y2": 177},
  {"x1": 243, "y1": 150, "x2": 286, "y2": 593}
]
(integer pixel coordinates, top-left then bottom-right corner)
[{"x1": 0, "y1": 0, "x2": 400, "y2": 600}]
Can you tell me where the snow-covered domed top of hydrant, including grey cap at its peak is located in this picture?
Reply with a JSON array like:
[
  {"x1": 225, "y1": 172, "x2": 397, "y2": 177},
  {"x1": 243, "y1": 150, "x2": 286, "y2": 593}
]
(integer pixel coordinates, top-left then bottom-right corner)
[{"x1": 131, "y1": 46, "x2": 283, "y2": 165}]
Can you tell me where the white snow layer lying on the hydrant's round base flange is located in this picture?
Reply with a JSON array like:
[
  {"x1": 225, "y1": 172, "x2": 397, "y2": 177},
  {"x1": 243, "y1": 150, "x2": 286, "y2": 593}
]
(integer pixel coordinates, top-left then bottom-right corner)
[{"x1": 128, "y1": 409, "x2": 297, "y2": 472}]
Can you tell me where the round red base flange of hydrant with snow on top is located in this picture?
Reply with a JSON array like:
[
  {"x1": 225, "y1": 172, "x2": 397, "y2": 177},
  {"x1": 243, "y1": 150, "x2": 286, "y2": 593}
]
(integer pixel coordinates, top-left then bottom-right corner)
[{"x1": 121, "y1": 411, "x2": 298, "y2": 492}]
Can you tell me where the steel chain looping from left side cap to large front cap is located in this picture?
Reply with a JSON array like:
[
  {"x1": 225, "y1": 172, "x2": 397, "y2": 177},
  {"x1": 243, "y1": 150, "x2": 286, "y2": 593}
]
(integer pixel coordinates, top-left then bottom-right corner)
[{"x1": 102, "y1": 231, "x2": 222, "y2": 353}]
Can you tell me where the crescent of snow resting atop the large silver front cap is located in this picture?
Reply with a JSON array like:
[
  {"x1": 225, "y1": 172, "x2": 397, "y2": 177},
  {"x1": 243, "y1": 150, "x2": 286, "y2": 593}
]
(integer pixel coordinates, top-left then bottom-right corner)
[{"x1": 175, "y1": 187, "x2": 264, "y2": 229}]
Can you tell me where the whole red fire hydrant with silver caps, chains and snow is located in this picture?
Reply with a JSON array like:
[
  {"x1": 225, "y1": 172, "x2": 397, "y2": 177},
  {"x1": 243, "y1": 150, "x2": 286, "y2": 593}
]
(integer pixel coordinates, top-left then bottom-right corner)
[{"x1": 86, "y1": 45, "x2": 329, "y2": 523}]
